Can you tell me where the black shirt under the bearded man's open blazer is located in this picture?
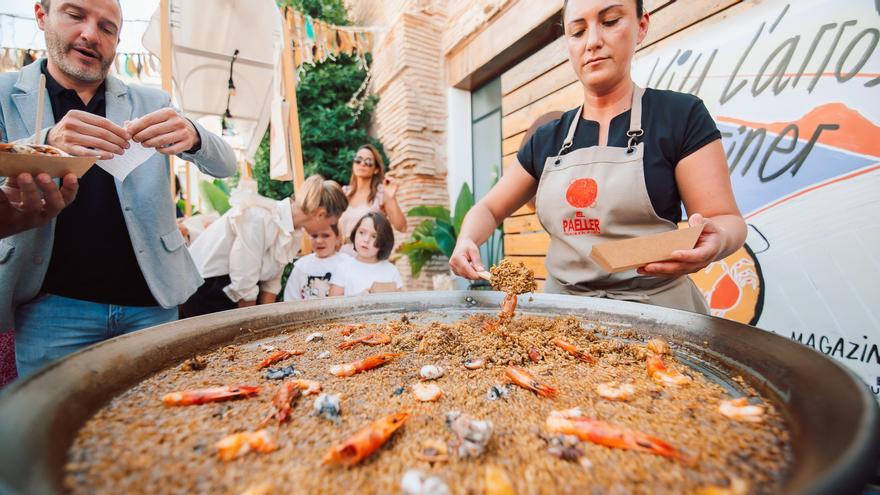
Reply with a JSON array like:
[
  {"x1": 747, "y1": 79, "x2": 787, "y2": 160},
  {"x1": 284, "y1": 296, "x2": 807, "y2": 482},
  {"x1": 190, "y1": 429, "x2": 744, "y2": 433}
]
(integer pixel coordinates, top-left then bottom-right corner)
[{"x1": 42, "y1": 61, "x2": 157, "y2": 306}]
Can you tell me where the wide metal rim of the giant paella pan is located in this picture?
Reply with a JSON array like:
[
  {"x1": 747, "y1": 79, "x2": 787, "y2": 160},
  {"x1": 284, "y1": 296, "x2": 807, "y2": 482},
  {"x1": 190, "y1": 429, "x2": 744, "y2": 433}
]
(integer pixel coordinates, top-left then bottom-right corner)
[{"x1": 0, "y1": 291, "x2": 880, "y2": 495}]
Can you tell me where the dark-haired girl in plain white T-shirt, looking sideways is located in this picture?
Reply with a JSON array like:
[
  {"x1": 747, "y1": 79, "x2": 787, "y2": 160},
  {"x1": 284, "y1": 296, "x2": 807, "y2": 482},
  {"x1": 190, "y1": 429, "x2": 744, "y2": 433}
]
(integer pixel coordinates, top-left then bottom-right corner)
[{"x1": 330, "y1": 212, "x2": 403, "y2": 296}]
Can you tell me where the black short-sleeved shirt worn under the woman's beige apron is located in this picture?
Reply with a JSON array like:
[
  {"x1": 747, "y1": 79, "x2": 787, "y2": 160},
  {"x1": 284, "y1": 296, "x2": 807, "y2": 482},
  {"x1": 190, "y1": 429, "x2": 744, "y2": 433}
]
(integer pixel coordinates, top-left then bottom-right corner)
[{"x1": 517, "y1": 89, "x2": 721, "y2": 223}]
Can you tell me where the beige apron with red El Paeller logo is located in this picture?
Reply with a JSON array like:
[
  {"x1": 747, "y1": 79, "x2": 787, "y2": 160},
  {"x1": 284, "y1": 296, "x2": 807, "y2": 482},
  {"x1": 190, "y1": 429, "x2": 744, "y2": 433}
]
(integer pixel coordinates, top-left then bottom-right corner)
[{"x1": 536, "y1": 81, "x2": 709, "y2": 314}]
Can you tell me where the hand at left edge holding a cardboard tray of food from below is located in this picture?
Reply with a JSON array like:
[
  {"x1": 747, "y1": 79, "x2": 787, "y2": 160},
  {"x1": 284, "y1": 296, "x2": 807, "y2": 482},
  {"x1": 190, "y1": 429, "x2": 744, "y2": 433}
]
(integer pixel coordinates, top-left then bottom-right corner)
[{"x1": 0, "y1": 173, "x2": 79, "y2": 238}]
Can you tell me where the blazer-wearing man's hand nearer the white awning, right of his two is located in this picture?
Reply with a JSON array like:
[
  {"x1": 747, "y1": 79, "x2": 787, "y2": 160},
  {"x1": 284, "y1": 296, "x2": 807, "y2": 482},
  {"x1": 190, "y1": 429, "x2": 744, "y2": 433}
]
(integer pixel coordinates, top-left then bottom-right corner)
[{"x1": 125, "y1": 107, "x2": 201, "y2": 155}]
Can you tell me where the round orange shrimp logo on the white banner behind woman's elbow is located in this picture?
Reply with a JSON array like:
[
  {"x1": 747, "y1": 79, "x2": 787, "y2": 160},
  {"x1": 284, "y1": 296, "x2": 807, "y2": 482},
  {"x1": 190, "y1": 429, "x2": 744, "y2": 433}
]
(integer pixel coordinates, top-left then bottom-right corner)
[{"x1": 691, "y1": 244, "x2": 764, "y2": 325}]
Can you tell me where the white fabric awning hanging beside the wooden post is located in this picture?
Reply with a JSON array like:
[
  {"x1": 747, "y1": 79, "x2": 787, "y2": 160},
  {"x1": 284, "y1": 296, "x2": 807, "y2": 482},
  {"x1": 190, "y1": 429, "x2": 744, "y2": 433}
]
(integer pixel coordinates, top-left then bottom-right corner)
[{"x1": 143, "y1": 0, "x2": 281, "y2": 162}]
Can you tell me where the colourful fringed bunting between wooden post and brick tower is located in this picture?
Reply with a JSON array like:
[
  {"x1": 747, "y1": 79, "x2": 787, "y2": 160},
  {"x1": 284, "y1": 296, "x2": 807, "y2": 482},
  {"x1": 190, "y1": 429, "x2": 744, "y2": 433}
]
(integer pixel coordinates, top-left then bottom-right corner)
[{"x1": 287, "y1": 10, "x2": 380, "y2": 67}]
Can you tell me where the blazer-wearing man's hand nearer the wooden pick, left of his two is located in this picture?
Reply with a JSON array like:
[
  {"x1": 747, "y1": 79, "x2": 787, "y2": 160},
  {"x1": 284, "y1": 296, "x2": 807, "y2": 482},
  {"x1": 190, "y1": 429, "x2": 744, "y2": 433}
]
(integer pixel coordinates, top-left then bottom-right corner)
[{"x1": 46, "y1": 110, "x2": 131, "y2": 160}]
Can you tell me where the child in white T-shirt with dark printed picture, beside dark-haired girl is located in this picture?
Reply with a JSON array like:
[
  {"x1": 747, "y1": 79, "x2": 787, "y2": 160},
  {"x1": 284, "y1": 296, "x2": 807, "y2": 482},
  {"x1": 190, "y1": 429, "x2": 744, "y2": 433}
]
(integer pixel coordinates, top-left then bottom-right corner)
[{"x1": 284, "y1": 224, "x2": 349, "y2": 301}]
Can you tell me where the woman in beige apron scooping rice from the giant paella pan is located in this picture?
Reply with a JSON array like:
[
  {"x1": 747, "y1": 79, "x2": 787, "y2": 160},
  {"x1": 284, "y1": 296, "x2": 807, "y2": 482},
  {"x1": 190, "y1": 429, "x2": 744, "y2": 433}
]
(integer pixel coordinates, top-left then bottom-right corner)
[{"x1": 449, "y1": 0, "x2": 746, "y2": 314}]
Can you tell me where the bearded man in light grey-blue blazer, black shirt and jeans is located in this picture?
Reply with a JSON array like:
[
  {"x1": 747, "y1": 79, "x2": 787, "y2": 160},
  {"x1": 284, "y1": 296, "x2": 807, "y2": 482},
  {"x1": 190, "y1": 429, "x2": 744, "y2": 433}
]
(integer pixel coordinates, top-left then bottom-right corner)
[{"x1": 0, "y1": 0, "x2": 236, "y2": 375}]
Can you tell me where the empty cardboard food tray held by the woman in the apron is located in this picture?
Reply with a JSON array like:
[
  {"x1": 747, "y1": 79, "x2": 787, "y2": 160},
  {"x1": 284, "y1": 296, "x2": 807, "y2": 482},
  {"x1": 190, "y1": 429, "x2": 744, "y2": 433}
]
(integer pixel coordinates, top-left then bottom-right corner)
[{"x1": 590, "y1": 226, "x2": 703, "y2": 273}]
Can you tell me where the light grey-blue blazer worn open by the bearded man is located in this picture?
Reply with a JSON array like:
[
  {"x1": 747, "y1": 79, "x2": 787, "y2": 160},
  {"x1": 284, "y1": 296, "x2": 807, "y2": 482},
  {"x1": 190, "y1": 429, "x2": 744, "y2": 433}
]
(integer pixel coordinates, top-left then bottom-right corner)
[{"x1": 0, "y1": 60, "x2": 236, "y2": 331}]
